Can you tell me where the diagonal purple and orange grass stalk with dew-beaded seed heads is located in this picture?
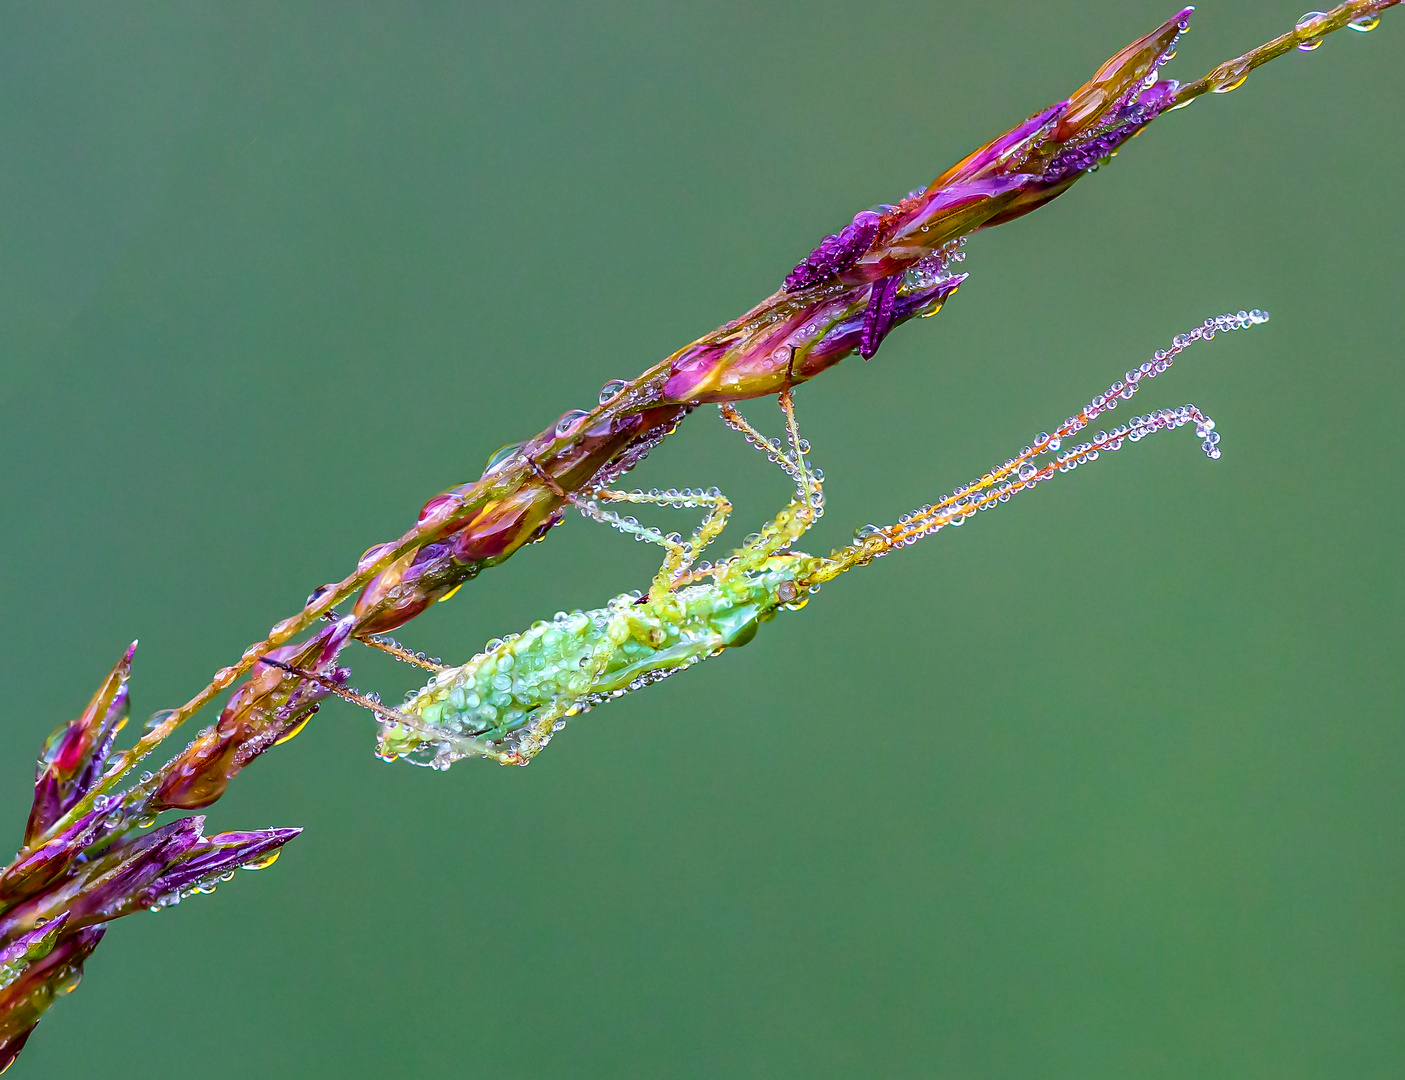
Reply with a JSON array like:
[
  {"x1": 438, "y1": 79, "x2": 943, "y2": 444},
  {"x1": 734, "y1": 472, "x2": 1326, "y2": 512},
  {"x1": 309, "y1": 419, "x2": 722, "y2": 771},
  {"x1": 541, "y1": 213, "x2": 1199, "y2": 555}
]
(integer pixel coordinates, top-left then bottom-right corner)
[{"x1": 0, "y1": 0, "x2": 1399, "y2": 1070}]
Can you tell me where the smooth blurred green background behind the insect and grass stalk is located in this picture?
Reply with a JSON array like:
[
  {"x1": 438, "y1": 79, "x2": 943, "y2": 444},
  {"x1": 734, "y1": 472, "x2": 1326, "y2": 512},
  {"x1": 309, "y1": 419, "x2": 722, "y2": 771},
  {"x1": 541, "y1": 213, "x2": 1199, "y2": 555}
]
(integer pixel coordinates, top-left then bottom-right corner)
[{"x1": 0, "y1": 0, "x2": 1405, "y2": 1079}]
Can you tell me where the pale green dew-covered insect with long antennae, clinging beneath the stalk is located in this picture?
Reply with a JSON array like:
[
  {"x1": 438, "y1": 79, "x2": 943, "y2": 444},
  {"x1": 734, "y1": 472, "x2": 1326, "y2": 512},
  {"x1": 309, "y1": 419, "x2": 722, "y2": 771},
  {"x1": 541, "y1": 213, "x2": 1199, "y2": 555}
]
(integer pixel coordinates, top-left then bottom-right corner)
[{"x1": 279, "y1": 310, "x2": 1267, "y2": 768}]
